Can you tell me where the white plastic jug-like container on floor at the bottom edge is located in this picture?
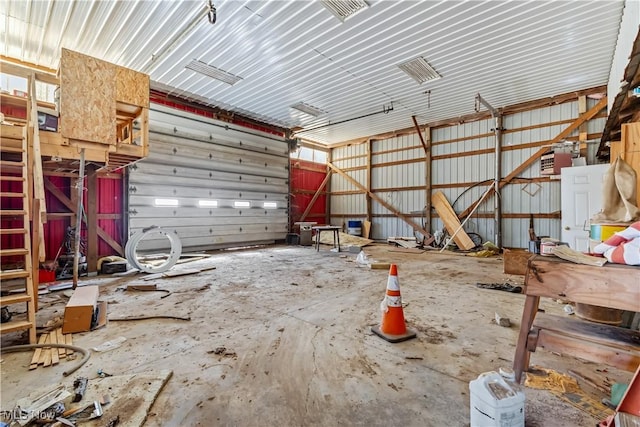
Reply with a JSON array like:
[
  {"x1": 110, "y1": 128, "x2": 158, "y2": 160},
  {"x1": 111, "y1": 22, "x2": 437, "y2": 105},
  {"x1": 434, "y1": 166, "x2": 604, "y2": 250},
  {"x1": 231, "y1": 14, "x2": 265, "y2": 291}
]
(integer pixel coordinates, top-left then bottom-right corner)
[{"x1": 469, "y1": 371, "x2": 525, "y2": 427}]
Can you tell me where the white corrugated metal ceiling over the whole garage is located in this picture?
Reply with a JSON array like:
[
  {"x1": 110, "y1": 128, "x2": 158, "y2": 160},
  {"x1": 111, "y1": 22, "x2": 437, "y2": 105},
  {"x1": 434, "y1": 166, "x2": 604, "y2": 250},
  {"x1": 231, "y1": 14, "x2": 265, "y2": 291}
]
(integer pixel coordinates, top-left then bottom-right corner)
[{"x1": 0, "y1": 0, "x2": 624, "y2": 144}]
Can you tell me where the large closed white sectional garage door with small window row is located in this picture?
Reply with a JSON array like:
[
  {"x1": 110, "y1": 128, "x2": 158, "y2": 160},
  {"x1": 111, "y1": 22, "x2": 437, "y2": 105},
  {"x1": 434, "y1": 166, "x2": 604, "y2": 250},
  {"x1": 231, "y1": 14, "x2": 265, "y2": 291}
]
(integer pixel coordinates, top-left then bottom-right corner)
[{"x1": 128, "y1": 104, "x2": 289, "y2": 251}]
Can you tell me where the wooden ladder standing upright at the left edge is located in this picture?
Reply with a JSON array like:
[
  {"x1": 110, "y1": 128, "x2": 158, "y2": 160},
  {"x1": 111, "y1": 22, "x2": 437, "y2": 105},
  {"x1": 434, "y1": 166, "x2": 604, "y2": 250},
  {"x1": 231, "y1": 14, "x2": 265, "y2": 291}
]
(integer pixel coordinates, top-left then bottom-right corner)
[{"x1": 0, "y1": 125, "x2": 39, "y2": 344}]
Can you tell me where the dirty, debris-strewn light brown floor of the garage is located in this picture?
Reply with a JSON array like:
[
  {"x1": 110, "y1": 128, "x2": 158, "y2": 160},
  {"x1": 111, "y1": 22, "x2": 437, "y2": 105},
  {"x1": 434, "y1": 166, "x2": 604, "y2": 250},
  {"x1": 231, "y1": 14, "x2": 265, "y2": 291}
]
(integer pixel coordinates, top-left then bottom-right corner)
[{"x1": 0, "y1": 244, "x2": 631, "y2": 427}]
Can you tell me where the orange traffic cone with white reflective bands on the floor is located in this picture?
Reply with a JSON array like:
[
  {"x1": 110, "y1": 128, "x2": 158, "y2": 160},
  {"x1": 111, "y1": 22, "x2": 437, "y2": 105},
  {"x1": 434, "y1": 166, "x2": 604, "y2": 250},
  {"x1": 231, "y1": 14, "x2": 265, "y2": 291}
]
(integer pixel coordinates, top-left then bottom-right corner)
[{"x1": 371, "y1": 264, "x2": 416, "y2": 343}]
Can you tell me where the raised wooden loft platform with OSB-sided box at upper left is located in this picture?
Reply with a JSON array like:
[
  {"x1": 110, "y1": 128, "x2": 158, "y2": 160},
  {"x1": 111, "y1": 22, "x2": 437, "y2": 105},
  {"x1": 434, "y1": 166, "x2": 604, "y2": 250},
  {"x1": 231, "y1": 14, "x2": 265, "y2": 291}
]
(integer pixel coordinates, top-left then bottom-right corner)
[{"x1": 1, "y1": 49, "x2": 149, "y2": 171}]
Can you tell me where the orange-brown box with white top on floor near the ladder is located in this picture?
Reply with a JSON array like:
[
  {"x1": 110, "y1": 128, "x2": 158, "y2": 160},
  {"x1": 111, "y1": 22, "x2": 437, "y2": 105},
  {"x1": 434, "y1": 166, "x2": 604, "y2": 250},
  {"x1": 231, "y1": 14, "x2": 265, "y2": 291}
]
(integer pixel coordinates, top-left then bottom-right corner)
[{"x1": 62, "y1": 286, "x2": 106, "y2": 334}]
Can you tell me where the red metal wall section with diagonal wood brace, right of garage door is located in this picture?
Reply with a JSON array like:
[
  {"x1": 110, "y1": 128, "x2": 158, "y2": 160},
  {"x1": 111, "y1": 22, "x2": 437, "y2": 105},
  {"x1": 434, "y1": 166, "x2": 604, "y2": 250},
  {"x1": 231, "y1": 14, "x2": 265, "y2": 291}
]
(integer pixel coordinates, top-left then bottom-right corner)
[{"x1": 289, "y1": 160, "x2": 327, "y2": 229}]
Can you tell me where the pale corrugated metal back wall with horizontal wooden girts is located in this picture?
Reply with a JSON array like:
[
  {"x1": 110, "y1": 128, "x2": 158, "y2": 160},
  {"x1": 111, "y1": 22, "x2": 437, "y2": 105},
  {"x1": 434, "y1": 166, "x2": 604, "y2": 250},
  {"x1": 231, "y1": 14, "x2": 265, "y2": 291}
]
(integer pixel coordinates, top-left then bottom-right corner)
[{"x1": 331, "y1": 99, "x2": 606, "y2": 248}]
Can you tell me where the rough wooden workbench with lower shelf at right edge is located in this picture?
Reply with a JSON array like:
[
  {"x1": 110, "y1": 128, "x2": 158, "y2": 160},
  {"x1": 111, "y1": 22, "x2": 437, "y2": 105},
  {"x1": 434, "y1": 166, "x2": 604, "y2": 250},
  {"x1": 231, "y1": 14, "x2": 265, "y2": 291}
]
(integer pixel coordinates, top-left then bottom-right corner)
[{"x1": 513, "y1": 255, "x2": 640, "y2": 381}]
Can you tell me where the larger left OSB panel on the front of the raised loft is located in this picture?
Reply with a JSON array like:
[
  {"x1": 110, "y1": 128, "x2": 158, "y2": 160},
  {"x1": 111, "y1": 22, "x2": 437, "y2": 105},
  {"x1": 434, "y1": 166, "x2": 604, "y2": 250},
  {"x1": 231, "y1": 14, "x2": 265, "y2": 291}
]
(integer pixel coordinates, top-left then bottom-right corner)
[{"x1": 60, "y1": 49, "x2": 116, "y2": 144}]
